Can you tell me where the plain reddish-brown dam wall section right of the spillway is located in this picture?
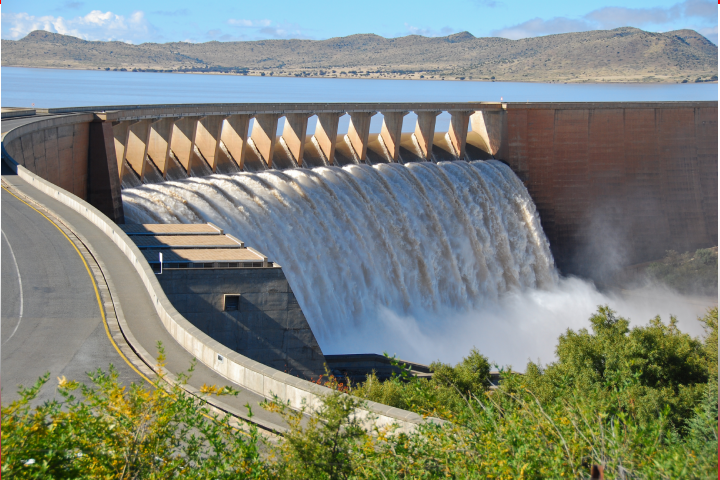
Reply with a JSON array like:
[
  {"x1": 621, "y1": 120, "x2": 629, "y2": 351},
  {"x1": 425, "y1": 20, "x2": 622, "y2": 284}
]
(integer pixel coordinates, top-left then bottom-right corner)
[{"x1": 497, "y1": 102, "x2": 718, "y2": 278}]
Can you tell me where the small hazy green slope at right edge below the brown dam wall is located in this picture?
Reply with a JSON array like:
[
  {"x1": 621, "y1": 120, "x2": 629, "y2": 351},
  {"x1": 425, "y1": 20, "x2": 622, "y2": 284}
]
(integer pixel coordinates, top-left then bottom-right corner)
[{"x1": 647, "y1": 247, "x2": 718, "y2": 296}]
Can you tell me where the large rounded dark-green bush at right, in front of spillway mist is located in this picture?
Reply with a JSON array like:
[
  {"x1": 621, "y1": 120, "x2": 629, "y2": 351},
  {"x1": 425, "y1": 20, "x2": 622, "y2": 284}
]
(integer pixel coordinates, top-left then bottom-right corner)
[{"x1": 527, "y1": 307, "x2": 708, "y2": 428}]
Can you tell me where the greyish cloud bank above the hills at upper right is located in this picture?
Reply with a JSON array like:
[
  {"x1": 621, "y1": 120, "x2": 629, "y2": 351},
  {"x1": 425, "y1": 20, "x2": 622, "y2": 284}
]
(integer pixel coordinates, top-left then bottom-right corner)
[{"x1": 492, "y1": 0, "x2": 717, "y2": 43}]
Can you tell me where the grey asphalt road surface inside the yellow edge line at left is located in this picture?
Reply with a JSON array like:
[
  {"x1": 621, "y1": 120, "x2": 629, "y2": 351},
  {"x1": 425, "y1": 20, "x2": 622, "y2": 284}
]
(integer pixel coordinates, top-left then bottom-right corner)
[{"x1": 0, "y1": 189, "x2": 143, "y2": 404}]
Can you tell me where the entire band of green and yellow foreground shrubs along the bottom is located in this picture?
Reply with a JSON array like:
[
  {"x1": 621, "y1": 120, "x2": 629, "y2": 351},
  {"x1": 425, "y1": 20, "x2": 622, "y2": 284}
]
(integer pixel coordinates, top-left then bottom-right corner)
[{"x1": 2, "y1": 307, "x2": 718, "y2": 479}]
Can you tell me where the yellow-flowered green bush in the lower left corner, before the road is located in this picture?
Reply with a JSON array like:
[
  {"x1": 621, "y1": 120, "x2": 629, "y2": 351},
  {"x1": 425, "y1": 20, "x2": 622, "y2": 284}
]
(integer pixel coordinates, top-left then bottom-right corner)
[{"x1": 2, "y1": 344, "x2": 265, "y2": 480}]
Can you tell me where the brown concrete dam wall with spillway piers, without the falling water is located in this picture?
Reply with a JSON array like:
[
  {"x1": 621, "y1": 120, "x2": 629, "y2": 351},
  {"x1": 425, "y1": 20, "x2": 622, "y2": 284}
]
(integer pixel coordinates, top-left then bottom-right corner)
[{"x1": 3, "y1": 102, "x2": 718, "y2": 280}]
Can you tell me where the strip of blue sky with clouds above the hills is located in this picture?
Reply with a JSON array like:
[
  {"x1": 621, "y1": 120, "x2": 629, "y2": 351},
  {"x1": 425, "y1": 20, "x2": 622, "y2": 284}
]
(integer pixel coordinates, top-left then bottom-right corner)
[{"x1": 2, "y1": 0, "x2": 718, "y2": 44}]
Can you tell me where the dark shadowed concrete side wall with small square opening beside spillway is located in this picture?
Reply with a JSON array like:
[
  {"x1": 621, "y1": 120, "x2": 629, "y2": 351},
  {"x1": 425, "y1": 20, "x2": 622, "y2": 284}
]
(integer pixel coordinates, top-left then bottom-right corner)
[{"x1": 156, "y1": 267, "x2": 325, "y2": 379}]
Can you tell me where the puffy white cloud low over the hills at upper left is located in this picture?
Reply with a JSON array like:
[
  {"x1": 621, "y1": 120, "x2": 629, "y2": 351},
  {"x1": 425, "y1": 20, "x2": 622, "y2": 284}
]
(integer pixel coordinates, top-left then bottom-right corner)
[{"x1": 2, "y1": 10, "x2": 155, "y2": 43}]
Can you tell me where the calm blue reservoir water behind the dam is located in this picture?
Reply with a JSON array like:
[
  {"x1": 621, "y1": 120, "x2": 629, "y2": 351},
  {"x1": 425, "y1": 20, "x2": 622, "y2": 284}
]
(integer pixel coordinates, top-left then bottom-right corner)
[{"x1": 0, "y1": 67, "x2": 718, "y2": 108}]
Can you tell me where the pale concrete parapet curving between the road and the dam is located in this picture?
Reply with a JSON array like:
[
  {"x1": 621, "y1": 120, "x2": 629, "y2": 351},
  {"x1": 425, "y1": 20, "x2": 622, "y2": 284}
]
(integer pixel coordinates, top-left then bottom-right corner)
[{"x1": 2, "y1": 115, "x2": 426, "y2": 432}]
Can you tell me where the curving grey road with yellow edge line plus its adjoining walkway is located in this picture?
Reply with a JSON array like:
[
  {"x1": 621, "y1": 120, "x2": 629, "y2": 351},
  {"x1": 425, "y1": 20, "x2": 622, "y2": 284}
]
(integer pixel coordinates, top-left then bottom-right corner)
[{"x1": 0, "y1": 113, "x2": 284, "y2": 432}]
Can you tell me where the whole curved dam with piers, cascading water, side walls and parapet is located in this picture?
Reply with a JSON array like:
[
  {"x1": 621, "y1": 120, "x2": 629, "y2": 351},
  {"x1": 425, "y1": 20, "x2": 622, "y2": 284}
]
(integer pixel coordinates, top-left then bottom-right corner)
[{"x1": 2, "y1": 102, "x2": 717, "y2": 428}]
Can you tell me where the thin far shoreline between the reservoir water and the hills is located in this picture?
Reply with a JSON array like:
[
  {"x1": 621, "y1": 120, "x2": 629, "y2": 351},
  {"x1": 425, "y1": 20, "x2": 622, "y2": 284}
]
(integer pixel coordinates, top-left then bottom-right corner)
[{"x1": 0, "y1": 65, "x2": 718, "y2": 85}]
